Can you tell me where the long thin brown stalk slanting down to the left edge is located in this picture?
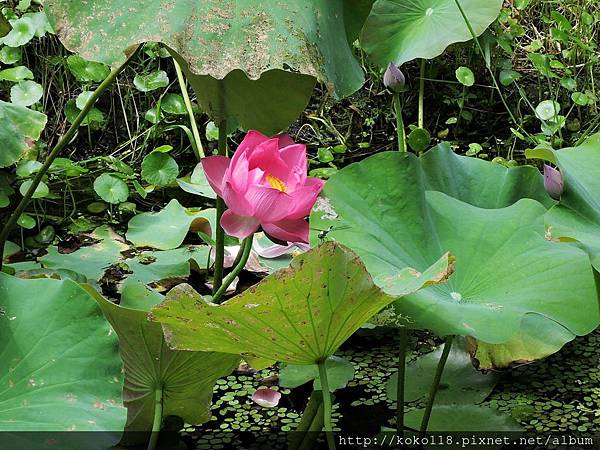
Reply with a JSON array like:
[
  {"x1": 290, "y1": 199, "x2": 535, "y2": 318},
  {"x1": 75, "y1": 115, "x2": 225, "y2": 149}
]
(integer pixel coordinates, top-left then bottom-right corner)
[{"x1": 0, "y1": 52, "x2": 135, "y2": 270}]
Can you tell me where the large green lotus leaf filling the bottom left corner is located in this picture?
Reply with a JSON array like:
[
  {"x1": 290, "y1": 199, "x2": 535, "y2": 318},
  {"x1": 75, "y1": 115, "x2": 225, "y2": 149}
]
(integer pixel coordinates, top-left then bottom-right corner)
[{"x1": 0, "y1": 273, "x2": 125, "y2": 434}]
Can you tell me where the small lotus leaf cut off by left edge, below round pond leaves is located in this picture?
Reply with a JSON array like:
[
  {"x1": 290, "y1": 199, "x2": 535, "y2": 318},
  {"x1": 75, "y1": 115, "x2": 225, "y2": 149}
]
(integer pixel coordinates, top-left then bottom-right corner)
[{"x1": 0, "y1": 100, "x2": 47, "y2": 167}]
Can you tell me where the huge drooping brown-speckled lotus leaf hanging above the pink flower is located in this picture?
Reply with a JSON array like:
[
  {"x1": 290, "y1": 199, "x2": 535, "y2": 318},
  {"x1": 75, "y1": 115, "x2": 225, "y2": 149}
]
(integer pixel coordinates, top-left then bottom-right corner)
[{"x1": 45, "y1": 0, "x2": 368, "y2": 134}]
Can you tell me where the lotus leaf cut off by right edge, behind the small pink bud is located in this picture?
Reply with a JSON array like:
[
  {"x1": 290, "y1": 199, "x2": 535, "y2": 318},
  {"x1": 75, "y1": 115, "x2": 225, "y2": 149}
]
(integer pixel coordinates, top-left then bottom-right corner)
[{"x1": 528, "y1": 133, "x2": 600, "y2": 272}]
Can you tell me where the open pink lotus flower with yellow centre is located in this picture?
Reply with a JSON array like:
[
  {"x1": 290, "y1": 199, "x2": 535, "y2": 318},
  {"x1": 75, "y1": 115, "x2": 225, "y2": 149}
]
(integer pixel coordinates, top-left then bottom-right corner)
[{"x1": 202, "y1": 131, "x2": 324, "y2": 242}]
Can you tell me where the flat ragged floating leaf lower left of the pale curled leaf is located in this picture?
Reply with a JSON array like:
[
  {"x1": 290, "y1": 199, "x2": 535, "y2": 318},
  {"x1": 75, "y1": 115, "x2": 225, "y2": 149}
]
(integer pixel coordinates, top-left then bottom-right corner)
[{"x1": 39, "y1": 225, "x2": 129, "y2": 281}]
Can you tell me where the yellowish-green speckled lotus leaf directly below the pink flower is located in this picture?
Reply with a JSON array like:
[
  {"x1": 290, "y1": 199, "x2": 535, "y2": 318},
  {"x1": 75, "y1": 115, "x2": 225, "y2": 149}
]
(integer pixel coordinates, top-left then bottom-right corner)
[{"x1": 151, "y1": 243, "x2": 448, "y2": 364}]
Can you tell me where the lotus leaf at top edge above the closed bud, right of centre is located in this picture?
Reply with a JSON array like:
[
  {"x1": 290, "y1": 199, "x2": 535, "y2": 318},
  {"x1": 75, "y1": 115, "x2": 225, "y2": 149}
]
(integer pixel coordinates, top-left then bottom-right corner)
[{"x1": 361, "y1": 0, "x2": 503, "y2": 67}]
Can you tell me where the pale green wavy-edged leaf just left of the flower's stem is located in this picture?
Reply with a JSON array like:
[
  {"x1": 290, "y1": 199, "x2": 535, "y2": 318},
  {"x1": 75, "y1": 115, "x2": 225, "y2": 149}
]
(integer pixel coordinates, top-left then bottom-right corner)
[{"x1": 126, "y1": 199, "x2": 208, "y2": 250}]
